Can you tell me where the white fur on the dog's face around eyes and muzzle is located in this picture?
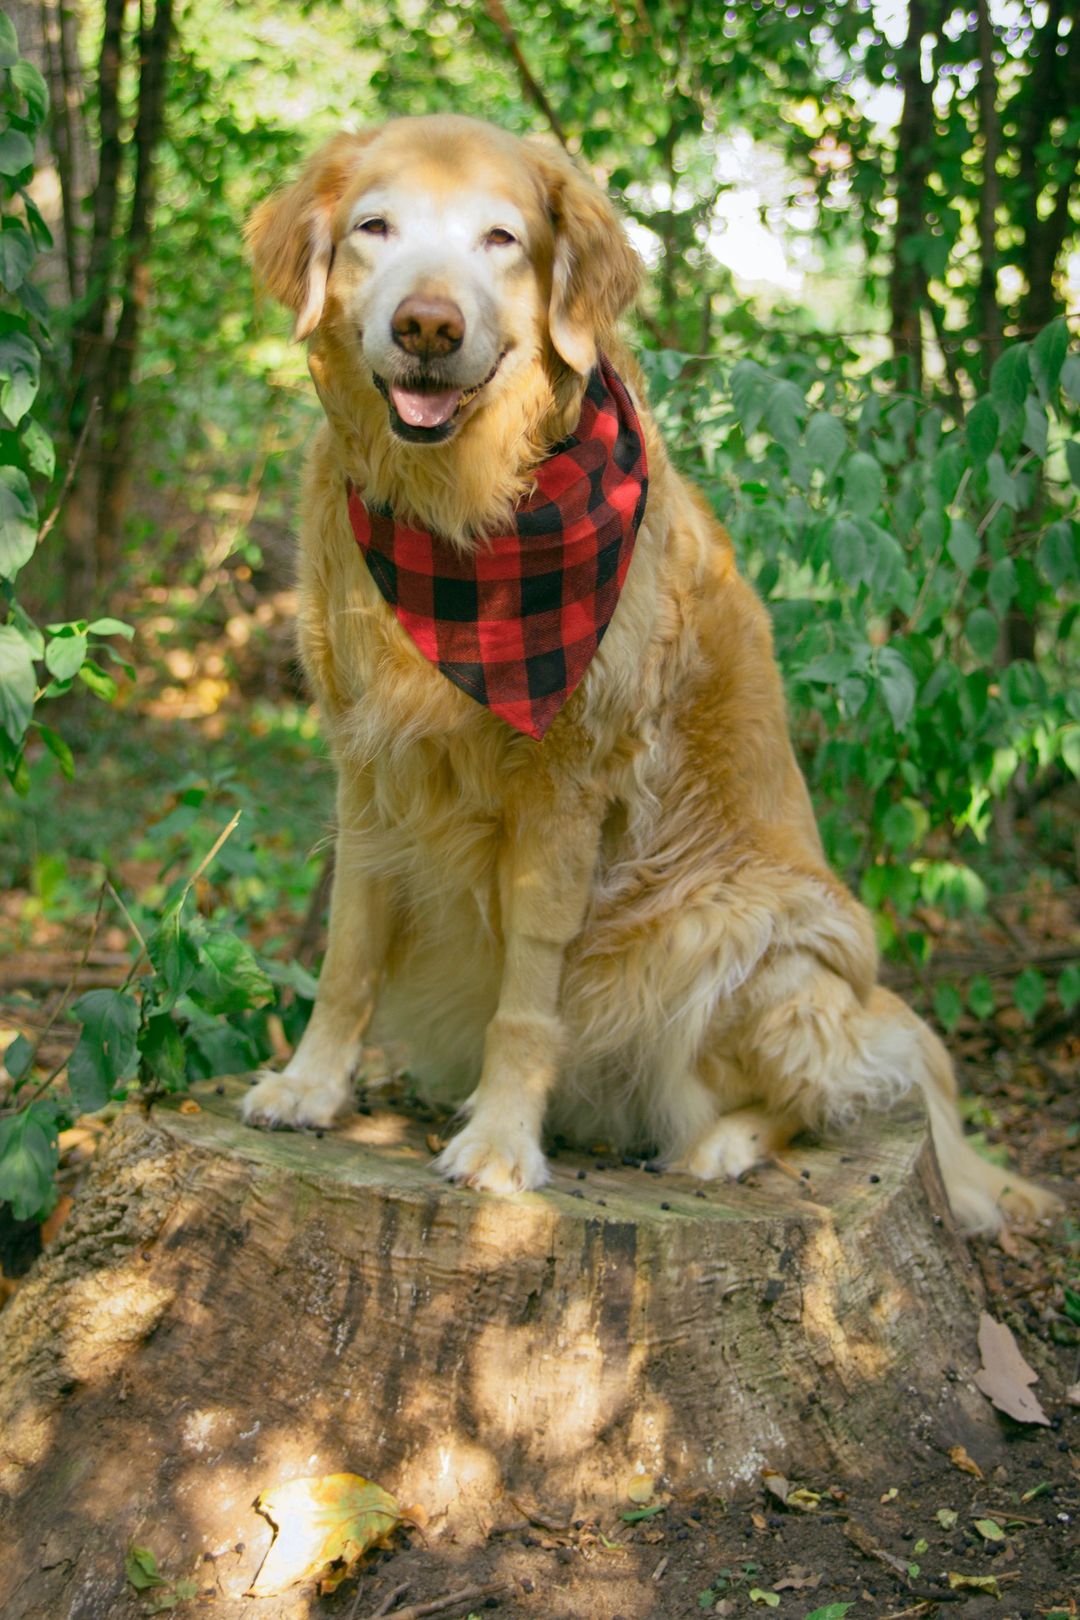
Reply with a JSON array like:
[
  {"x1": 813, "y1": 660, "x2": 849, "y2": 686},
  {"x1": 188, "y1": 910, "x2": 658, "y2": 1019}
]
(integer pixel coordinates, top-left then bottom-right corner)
[{"x1": 338, "y1": 185, "x2": 528, "y2": 389}]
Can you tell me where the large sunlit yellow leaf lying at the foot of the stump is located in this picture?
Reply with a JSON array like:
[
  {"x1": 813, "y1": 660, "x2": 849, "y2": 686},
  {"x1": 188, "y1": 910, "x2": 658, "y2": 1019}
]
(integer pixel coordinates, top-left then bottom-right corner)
[{"x1": 248, "y1": 1474, "x2": 402, "y2": 1597}]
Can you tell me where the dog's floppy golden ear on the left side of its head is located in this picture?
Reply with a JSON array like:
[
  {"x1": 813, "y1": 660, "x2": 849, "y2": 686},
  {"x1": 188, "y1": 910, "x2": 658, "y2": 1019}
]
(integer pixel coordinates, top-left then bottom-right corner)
[{"x1": 244, "y1": 131, "x2": 374, "y2": 339}]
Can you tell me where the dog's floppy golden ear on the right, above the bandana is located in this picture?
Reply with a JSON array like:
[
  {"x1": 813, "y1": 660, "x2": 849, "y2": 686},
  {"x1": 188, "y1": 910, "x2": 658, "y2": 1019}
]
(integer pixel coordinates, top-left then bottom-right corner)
[{"x1": 526, "y1": 141, "x2": 641, "y2": 376}]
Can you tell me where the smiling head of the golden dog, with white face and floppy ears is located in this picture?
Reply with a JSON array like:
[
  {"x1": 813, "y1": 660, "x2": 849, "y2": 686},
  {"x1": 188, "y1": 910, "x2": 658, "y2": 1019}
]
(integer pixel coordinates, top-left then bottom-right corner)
[{"x1": 248, "y1": 117, "x2": 638, "y2": 446}]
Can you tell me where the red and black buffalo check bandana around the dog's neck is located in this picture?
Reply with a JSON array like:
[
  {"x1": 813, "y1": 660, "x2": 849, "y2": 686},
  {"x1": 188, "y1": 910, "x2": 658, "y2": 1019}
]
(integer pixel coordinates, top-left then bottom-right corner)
[{"x1": 348, "y1": 356, "x2": 648, "y2": 740}]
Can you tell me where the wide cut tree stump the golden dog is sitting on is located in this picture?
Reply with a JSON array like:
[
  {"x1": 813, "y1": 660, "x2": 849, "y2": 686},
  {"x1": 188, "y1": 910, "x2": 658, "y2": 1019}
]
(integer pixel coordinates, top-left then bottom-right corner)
[{"x1": 0, "y1": 1082, "x2": 996, "y2": 1620}]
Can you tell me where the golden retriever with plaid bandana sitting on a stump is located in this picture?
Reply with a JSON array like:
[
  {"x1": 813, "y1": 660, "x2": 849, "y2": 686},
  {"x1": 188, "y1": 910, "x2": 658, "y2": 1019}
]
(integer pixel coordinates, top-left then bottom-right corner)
[{"x1": 243, "y1": 115, "x2": 1054, "y2": 1230}]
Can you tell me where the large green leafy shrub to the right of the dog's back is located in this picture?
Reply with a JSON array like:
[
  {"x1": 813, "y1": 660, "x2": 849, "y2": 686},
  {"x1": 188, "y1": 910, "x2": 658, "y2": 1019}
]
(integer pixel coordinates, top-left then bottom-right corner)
[{"x1": 649, "y1": 321, "x2": 1080, "y2": 1029}]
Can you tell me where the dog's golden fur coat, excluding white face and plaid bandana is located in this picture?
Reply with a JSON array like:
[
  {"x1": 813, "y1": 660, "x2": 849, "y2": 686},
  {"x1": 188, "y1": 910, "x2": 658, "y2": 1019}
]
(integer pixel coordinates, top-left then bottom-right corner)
[{"x1": 246, "y1": 118, "x2": 1052, "y2": 1228}]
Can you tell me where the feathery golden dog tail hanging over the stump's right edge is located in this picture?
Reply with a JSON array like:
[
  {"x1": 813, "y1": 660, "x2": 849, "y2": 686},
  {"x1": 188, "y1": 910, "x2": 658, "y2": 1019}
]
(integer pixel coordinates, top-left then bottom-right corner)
[{"x1": 871, "y1": 988, "x2": 1061, "y2": 1231}]
